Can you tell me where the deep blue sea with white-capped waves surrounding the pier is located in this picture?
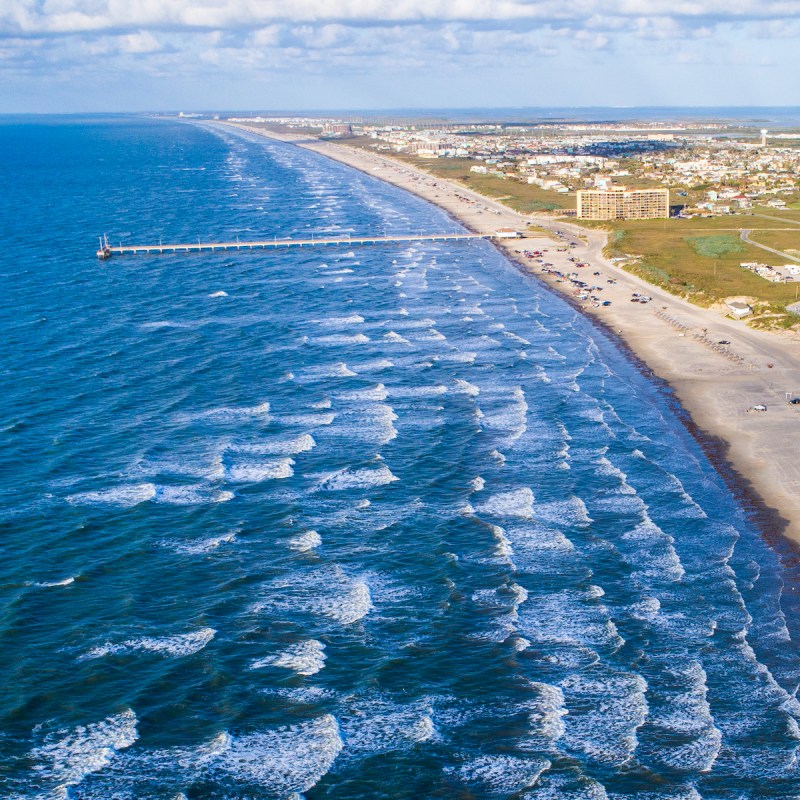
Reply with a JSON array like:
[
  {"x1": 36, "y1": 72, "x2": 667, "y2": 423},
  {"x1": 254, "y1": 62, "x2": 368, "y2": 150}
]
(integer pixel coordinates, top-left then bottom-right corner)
[{"x1": 0, "y1": 119, "x2": 800, "y2": 800}]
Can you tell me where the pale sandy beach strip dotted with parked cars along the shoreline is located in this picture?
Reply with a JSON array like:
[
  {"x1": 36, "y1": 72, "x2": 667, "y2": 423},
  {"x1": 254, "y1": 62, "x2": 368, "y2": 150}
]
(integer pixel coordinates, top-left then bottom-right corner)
[{"x1": 227, "y1": 125, "x2": 800, "y2": 542}]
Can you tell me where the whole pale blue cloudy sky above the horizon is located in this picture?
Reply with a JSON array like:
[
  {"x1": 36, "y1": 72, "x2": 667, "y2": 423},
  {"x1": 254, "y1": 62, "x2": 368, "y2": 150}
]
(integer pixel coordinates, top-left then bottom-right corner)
[{"x1": 0, "y1": 0, "x2": 800, "y2": 113}]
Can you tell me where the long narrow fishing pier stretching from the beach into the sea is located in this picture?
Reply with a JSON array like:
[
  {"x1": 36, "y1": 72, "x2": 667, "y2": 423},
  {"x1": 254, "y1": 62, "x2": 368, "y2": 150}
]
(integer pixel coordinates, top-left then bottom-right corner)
[{"x1": 97, "y1": 231, "x2": 508, "y2": 259}]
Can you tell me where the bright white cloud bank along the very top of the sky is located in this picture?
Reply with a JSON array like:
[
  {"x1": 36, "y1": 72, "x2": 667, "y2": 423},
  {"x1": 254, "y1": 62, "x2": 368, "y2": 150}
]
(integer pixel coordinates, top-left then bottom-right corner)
[{"x1": 0, "y1": 0, "x2": 800, "y2": 35}]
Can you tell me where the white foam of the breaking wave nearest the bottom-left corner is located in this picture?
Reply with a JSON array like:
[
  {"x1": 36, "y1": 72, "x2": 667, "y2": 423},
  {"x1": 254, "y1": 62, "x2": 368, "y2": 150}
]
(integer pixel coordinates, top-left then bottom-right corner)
[{"x1": 30, "y1": 709, "x2": 139, "y2": 798}]
